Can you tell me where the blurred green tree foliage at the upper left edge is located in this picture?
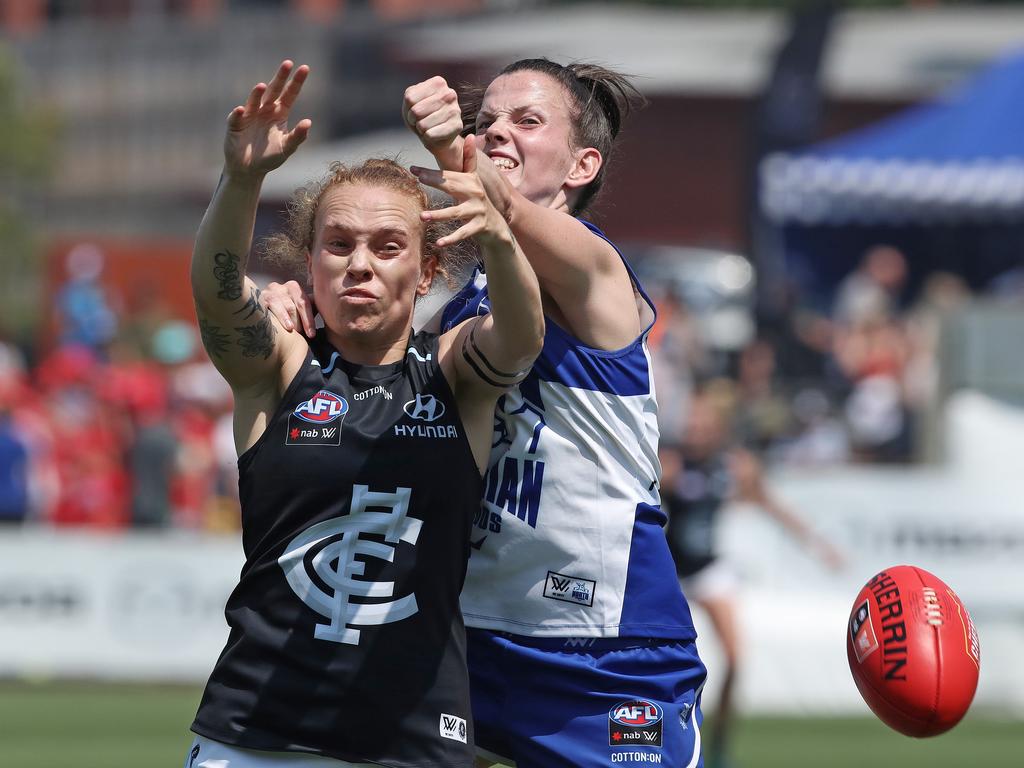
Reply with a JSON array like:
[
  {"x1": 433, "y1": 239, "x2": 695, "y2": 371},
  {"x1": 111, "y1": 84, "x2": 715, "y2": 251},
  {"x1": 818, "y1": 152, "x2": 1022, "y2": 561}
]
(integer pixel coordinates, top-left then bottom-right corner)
[{"x1": 0, "y1": 43, "x2": 57, "y2": 344}]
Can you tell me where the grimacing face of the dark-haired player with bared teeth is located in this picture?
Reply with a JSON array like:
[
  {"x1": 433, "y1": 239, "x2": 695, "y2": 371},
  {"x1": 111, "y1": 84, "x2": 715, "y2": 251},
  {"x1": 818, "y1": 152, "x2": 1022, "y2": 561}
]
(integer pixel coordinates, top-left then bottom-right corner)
[{"x1": 476, "y1": 70, "x2": 593, "y2": 206}]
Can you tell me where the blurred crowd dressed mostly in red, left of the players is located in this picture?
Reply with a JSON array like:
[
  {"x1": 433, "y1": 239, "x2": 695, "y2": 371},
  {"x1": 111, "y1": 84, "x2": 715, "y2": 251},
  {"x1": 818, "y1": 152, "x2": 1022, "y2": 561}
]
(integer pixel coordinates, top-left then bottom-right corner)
[{"x1": 0, "y1": 246, "x2": 239, "y2": 530}]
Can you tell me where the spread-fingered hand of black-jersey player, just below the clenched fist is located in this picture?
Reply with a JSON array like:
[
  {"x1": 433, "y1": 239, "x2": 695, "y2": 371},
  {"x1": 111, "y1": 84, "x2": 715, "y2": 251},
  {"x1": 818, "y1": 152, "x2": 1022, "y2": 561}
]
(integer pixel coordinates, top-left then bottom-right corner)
[{"x1": 411, "y1": 135, "x2": 515, "y2": 249}]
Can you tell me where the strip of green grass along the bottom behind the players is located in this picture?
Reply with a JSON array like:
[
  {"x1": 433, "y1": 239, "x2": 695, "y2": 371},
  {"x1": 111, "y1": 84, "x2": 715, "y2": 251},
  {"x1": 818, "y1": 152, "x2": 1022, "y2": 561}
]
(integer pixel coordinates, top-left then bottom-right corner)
[{"x1": 0, "y1": 683, "x2": 1024, "y2": 768}]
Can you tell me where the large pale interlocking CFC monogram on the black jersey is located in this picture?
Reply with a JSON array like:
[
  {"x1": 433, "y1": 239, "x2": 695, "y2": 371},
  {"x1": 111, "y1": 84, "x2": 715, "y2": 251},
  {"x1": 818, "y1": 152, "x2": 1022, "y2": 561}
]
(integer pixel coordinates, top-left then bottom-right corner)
[{"x1": 278, "y1": 485, "x2": 423, "y2": 645}]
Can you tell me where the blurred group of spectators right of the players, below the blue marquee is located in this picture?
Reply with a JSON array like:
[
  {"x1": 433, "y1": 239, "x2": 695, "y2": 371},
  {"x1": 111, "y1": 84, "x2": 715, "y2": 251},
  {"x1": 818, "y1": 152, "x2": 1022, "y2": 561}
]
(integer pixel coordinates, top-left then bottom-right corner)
[{"x1": 651, "y1": 245, "x2": 972, "y2": 466}]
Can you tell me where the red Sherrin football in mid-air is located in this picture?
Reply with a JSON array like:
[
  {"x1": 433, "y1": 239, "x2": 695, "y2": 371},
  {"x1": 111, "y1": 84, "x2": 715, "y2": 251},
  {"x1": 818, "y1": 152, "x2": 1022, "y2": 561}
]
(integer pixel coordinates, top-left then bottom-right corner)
[{"x1": 846, "y1": 565, "x2": 981, "y2": 737}]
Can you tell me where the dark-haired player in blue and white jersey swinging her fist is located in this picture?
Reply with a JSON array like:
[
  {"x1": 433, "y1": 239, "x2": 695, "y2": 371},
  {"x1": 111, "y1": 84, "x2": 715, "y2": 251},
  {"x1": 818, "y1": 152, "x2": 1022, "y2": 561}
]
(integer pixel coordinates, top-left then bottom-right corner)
[{"x1": 271, "y1": 59, "x2": 706, "y2": 768}]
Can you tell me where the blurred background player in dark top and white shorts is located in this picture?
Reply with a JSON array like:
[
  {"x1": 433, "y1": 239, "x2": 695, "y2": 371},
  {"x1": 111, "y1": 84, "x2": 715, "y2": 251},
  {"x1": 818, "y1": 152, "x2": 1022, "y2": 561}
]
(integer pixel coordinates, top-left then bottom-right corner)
[{"x1": 660, "y1": 387, "x2": 843, "y2": 768}]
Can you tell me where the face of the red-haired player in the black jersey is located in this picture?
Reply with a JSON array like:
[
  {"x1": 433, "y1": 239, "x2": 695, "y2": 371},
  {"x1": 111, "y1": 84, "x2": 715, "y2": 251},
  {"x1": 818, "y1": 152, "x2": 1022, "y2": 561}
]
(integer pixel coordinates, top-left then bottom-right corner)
[{"x1": 307, "y1": 183, "x2": 435, "y2": 335}]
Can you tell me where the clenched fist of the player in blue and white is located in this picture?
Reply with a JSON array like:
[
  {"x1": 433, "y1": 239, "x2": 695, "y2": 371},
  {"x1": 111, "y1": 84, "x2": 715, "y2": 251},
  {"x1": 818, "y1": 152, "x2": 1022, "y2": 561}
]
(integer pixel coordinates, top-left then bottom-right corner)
[{"x1": 401, "y1": 77, "x2": 462, "y2": 170}]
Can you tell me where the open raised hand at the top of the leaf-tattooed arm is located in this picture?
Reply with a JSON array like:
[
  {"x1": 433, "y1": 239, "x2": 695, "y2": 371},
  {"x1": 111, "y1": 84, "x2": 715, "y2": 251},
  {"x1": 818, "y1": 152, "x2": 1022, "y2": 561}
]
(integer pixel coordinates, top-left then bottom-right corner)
[{"x1": 224, "y1": 59, "x2": 312, "y2": 181}]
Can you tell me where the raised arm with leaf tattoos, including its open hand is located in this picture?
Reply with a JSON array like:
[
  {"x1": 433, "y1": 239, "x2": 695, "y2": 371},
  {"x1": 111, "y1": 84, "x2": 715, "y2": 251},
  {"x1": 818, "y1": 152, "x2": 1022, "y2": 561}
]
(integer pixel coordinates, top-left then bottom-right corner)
[{"x1": 191, "y1": 61, "x2": 310, "y2": 394}]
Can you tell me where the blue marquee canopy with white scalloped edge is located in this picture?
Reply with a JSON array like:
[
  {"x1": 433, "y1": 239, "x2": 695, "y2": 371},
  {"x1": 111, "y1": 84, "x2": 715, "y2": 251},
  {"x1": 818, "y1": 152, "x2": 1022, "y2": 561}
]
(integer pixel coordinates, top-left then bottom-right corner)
[{"x1": 760, "y1": 51, "x2": 1024, "y2": 225}]
